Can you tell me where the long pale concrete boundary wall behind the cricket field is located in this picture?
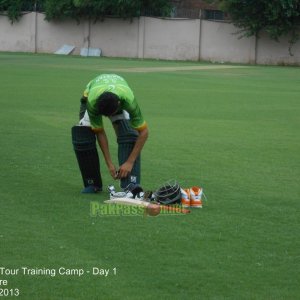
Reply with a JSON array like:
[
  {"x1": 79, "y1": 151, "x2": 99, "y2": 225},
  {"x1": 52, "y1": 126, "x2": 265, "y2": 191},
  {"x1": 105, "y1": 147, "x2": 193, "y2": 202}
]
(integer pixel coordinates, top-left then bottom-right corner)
[{"x1": 0, "y1": 12, "x2": 300, "y2": 64}]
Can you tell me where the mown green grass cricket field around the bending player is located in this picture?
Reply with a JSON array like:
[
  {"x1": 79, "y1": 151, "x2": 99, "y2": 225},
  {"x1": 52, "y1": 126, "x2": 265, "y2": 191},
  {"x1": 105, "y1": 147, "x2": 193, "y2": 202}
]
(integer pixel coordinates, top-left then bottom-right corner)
[{"x1": 0, "y1": 53, "x2": 300, "y2": 300}]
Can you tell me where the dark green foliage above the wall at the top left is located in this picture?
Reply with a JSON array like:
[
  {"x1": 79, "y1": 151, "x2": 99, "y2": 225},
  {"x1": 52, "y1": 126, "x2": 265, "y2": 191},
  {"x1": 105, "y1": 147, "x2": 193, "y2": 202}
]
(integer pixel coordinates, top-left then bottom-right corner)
[{"x1": 0, "y1": 0, "x2": 171, "y2": 22}]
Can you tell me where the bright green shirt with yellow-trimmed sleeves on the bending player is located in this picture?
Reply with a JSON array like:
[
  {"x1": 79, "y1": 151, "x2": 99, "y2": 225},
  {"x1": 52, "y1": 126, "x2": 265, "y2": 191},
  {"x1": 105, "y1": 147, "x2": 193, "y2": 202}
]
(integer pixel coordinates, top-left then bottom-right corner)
[{"x1": 83, "y1": 74, "x2": 147, "y2": 131}]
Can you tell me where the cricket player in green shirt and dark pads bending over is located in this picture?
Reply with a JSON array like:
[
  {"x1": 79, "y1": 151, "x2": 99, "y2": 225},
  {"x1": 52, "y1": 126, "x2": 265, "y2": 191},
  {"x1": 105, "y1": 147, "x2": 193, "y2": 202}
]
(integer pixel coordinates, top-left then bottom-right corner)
[{"x1": 72, "y1": 74, "x2": 148, "y2": 193}]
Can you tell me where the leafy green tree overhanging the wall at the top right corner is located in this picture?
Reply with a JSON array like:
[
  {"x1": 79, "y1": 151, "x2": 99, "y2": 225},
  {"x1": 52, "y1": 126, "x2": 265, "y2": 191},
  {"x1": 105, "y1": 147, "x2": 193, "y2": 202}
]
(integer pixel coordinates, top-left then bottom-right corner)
[{"x1": 218, "y1": 0, "x2": 300, "y2": 55}]
